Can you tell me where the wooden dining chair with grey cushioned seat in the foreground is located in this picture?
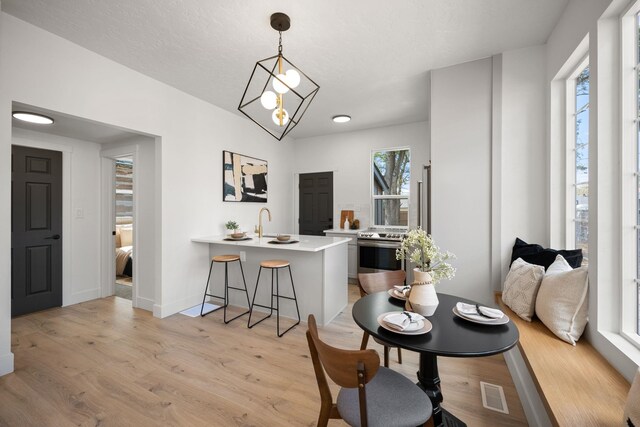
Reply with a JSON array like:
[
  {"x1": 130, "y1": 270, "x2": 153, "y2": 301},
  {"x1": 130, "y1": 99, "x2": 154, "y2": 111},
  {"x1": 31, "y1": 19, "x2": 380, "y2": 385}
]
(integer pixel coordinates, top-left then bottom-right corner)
[{"x1": 307, "y1": 314, "x2": 433, "y2": 427}]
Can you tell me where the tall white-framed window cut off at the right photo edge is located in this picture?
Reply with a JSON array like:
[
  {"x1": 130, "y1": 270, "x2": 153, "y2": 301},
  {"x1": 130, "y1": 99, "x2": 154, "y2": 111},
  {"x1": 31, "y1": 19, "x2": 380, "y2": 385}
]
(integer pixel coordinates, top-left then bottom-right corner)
[{"x1": 620, "y1": 1, "x2": 640, "y2": 348}]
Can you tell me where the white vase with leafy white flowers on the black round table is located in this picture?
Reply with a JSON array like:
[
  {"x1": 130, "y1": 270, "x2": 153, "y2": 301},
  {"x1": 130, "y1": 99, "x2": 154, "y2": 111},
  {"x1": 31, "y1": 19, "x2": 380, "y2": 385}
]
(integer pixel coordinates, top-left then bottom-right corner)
[{"x1": 396, "y1": 228, "x2": 456, "y2": 316}]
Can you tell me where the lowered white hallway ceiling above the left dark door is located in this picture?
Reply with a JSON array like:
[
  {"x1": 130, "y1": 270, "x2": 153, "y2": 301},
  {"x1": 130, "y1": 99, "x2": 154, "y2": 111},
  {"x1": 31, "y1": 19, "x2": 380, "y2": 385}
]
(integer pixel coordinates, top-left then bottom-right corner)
[{"x1": 11, "y1": 102, "x2": 140, "y2": 144}]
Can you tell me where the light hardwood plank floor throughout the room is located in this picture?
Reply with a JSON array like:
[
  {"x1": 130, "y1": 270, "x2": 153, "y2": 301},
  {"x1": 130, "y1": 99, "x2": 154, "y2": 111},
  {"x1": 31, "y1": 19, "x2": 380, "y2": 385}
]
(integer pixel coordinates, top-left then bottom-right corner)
[{"x1": 0, "y1": 286, "x2": 526, "y2": 427}]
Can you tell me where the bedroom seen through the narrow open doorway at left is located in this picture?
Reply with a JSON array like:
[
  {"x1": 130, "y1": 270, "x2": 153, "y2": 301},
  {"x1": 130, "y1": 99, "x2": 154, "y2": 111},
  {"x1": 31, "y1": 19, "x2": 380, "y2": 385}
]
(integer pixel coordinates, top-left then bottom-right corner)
[{"x1": 113, "y1": 156, "x2": 135, "y2": 301}]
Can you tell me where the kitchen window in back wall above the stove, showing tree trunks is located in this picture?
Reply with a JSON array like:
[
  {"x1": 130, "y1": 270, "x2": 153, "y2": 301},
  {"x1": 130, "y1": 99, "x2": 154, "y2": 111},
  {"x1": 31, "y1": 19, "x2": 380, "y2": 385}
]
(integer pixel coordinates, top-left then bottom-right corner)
[{"x1": 371, "y1": 148, "x2": 411, "y2": 227}]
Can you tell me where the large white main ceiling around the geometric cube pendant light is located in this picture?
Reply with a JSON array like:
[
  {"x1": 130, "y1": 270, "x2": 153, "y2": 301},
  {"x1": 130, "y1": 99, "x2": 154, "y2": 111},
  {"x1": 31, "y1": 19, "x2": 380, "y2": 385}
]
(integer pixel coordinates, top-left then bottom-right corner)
[{"x1": 1, "y1": 0, "x2": 568, "y2": 138}]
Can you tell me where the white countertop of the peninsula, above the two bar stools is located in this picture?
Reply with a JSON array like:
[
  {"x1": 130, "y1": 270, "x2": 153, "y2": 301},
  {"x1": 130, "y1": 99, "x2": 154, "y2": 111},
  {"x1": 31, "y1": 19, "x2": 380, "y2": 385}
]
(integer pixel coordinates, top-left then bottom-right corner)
[{"x1": 191, "y1": 236, "x2": 350, "y2": 252}]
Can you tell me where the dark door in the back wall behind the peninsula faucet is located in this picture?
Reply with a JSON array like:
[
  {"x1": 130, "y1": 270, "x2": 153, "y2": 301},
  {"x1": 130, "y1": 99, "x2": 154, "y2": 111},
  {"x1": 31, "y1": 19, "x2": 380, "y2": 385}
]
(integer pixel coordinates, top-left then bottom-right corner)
[{"x1": 299, "y1": 172, "x2": 333, "y2": 236}]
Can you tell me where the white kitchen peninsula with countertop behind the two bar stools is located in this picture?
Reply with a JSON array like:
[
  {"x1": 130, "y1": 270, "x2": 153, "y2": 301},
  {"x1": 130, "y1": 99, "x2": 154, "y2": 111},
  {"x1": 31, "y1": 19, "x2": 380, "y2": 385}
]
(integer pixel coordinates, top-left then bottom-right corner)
[{"x1": 191, "y1": 235, "x2": 351, "y2": 325}]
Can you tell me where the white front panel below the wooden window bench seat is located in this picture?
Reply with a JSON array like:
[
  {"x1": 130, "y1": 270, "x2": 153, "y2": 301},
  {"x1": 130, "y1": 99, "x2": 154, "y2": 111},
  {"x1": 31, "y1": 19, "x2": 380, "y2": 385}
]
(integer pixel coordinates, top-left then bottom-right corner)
[{"x1": 503, "y1": 346, "x2": 552, "y2": 427}]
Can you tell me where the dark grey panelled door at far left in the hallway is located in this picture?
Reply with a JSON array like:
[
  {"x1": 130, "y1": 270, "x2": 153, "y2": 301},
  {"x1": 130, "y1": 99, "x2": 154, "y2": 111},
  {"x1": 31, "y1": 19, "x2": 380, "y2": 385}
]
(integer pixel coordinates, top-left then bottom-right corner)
[{"x1": 11, "y1": 146, "x2": 62, "y2": 316}]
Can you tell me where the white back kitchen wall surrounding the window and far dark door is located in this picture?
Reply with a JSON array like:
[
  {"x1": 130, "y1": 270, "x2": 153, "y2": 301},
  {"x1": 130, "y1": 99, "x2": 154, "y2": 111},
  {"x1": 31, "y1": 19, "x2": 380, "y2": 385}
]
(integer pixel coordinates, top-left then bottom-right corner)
[{"x1": 293, "y1": 122, "x2": 429, "y2": 230}]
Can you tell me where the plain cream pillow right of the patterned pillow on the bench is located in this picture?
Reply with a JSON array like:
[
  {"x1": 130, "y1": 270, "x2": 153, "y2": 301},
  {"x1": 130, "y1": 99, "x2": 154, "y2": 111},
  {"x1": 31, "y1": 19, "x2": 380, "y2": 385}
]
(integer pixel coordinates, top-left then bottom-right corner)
[{"x1": 536, "y1": 255, "x2": 589, "y2": 345}]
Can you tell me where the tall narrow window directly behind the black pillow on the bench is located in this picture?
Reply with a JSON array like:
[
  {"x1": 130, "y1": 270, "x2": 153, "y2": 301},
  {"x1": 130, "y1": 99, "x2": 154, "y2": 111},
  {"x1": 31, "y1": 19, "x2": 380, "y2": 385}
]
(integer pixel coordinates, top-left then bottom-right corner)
[{"x1": 573, "y1": 65, "x2": 589, "y2": 262}]
